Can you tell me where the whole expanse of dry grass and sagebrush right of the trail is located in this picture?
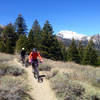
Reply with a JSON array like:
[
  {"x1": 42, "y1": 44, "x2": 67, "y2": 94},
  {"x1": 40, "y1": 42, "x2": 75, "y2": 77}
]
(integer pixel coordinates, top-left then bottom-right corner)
[{"x1": 44, "y1": 59, "x2": 100, "y2": 100}]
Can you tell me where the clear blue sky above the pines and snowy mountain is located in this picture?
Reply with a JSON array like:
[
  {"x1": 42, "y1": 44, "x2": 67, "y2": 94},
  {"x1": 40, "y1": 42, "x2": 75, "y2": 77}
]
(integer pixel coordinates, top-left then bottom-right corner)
[{"x1": 0, "y1": 0, "x2": 100, "y2": 35}]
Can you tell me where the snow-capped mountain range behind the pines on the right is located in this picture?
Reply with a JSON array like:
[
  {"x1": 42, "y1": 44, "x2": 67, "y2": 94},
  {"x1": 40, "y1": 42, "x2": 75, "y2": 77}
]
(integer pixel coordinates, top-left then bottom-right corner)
[{"x1": 56, "y1": 30, "x2": 100, "y2": 50}]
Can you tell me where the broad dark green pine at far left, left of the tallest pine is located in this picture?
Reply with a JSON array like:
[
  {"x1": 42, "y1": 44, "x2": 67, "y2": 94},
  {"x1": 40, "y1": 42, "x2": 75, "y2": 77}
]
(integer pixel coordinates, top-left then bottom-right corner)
[{"x1": 1, "y1": 23, "x2": 17, "y2": 53}]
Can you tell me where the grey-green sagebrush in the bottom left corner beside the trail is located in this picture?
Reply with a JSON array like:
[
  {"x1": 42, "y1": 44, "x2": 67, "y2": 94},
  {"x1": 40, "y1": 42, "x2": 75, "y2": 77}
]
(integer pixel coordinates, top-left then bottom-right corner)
[{"x1": 0, "y1": 76, "x2": 32, "y2": 100}]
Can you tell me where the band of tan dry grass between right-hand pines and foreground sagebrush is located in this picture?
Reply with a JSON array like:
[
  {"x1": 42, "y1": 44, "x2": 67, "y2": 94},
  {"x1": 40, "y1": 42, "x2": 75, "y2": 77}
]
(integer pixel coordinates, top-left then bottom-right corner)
[{"x1": 42, "y1": 59, "x2": 100, "y2": 87}]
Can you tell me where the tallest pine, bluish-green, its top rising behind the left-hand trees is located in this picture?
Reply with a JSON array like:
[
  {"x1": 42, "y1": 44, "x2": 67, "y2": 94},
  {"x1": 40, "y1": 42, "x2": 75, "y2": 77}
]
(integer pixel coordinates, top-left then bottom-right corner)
[{"x1": 15, "y1": 14, "x2": 27, "y2": 37}]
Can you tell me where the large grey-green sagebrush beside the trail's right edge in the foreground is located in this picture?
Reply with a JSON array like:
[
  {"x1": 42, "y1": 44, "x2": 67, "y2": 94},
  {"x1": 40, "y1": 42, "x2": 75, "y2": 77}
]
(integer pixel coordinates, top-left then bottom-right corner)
[{"x1": 51, "y1": 74, "x2": 85, "y2": 100}]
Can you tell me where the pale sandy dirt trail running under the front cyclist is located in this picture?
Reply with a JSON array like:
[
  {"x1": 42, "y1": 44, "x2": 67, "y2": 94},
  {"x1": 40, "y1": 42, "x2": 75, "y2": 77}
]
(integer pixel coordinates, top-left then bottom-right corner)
[{"x1": 16, "y1": 58, "x2": 57, "y2": 100}]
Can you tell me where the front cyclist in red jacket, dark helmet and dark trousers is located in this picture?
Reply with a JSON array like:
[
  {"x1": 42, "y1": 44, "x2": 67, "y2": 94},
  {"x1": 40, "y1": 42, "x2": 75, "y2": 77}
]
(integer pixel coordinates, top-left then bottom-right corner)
[{"x1": 29, "y1": 48, "x2": 43, "y2": 80}]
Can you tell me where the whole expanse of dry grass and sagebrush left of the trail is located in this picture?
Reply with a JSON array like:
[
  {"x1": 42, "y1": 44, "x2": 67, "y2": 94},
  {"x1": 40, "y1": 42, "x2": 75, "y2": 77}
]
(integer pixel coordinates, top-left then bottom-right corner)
[{"x1": 0, "y1": 53, "x2": 33, "y2": 100}]
